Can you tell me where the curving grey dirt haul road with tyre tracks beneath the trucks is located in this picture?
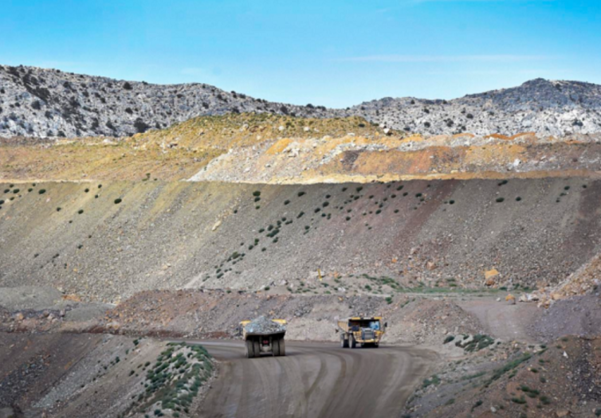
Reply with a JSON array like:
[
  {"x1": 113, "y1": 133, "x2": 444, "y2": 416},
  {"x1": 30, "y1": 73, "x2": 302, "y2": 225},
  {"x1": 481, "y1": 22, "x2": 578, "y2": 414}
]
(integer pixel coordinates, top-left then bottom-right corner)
[{"x1": 199, "y1": 341, "x2": 438, "y2": 418}]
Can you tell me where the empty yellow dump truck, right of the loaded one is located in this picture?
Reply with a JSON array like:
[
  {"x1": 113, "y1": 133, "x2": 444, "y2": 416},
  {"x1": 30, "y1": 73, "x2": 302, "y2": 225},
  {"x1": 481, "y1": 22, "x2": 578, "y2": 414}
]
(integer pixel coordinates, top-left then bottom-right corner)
[{"x1": 336, "y1": 316, "x2": 388, "y2": 348}]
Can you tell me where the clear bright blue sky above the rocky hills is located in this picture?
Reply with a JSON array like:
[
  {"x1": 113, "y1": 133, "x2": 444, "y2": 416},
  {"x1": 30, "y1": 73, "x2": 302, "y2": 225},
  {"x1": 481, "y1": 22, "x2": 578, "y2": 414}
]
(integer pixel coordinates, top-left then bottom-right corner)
[{"x1": 0, "y1": 0, "x2": 601, "y2": 107}]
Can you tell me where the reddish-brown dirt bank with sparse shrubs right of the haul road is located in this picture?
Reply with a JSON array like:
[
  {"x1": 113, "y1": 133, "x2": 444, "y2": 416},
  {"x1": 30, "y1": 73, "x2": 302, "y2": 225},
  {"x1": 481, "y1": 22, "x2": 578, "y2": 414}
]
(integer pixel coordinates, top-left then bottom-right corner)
[{"x1": 407, "y1": 337, "x2": 601, "y2": 418}]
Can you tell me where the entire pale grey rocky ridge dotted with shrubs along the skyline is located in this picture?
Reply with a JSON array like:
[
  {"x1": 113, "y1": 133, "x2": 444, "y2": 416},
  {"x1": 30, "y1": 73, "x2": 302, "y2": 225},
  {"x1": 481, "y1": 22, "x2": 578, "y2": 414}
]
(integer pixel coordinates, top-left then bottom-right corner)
[{"x1": 0, "y1": 66, "x2": 601, "y2": 138}]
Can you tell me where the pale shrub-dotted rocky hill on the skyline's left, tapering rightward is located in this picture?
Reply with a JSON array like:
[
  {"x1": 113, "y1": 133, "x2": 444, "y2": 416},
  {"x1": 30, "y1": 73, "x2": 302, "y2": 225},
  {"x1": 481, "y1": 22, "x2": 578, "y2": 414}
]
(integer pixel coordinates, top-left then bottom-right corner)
[{"x1": 0, "y1": 66, "x2": 331, "y2": 138}]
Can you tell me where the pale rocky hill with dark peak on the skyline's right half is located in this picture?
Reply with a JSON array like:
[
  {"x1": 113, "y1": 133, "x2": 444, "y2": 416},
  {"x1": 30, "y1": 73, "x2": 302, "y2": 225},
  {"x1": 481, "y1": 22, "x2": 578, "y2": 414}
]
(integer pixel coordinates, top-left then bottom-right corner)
[{"x1": 352, "y1": 79, "x2": 601, "y2": 136}]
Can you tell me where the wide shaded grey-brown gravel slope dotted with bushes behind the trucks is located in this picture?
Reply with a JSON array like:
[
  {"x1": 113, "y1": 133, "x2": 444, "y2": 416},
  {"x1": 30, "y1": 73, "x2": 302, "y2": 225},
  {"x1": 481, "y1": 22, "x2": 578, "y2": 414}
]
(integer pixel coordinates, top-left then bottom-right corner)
[{"x1": 0, "y1": 178, "x2": 601, "y2": 302}]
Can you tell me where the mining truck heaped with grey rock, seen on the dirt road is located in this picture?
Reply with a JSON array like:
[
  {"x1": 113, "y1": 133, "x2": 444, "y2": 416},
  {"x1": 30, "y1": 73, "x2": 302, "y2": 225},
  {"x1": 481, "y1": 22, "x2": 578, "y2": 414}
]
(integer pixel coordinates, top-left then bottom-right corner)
[{"x1": 240, "y1": 317, "x2": 286, "y2": 358}]
